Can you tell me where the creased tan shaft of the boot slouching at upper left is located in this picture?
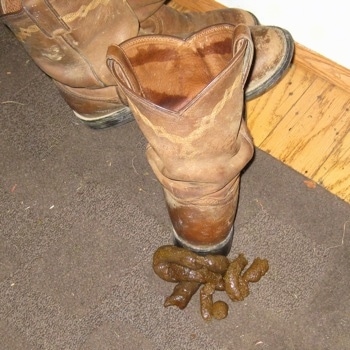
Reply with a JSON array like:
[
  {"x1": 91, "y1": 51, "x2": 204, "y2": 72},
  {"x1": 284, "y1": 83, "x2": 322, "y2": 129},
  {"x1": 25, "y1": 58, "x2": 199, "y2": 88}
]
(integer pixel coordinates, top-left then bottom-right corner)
[{"x1": 1, "y1": 0, "x2": 139, "y2": 88}]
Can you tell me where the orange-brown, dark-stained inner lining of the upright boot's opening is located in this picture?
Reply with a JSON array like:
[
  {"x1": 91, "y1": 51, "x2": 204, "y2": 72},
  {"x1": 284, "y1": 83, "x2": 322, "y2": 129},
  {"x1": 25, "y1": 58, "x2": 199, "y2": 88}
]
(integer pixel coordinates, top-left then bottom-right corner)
[{"x1": 124, "y1": 33, "x2": 233, "y2": 112}]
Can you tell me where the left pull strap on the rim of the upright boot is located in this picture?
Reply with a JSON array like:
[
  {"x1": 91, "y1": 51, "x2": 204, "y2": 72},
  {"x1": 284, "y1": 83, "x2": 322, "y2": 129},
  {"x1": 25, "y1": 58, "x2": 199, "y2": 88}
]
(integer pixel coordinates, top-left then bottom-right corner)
[{"x1": 106, "y1": 45, "x2": 144, "y2": 96}]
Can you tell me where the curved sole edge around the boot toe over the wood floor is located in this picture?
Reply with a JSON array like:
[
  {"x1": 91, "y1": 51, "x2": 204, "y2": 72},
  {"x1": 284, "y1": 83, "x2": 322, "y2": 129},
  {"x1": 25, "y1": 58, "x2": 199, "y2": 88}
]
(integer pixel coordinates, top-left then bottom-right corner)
[{"x1": 245, "y1": 28, "x2": 294, "y2": 101}]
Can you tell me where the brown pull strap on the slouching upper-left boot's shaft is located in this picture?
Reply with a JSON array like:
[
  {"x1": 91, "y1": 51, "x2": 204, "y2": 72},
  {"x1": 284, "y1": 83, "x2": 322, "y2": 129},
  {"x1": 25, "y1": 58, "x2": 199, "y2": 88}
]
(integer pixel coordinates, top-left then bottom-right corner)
[{"x1": 22, "y1": 0, "x2": 70, "y2": 38}]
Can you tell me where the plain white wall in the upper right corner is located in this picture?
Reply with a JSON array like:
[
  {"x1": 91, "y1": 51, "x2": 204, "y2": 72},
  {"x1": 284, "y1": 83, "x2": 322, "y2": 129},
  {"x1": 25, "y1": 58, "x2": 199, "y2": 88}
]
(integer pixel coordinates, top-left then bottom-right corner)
[{"x1": 217, "y1": 0, "x2": 350, "y2": 69}]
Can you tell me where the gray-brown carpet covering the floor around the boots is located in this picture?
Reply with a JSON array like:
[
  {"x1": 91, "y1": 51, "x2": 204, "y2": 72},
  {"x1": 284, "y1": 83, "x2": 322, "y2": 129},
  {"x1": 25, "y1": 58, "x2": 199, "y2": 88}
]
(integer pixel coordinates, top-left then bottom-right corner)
[{"x1": 0, "y1": 26, "x2": 350, "y2": 350}]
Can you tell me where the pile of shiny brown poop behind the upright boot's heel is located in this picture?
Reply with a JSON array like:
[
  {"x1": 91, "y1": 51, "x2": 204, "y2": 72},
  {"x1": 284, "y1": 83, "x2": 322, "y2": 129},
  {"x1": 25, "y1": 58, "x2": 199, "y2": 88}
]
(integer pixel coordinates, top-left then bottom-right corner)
[{"x1": 153, "y1": 245, "x2": 269, "y2": 320}]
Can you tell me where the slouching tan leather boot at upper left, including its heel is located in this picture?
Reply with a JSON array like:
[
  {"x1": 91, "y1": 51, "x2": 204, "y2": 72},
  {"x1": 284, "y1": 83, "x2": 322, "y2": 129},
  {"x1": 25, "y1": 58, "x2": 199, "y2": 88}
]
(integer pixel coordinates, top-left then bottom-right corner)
[{"x1": 0, "y1": 0, "x2": 139, "y2": 128}]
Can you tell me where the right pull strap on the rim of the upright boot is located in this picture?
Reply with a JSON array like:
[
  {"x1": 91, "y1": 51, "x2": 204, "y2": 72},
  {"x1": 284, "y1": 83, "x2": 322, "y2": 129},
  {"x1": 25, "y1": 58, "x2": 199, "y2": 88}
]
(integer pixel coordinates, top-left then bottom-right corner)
[{"x1": 233, "y1": 25, "x2": 254, "y2": 86}]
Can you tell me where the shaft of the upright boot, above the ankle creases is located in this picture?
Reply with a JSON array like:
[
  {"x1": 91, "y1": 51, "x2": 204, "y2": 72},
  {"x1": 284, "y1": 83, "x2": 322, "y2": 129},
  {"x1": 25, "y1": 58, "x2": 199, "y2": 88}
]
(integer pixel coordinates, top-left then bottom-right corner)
[{"x1": 109, "y1": 25, "x2": 253, "y2": 187}]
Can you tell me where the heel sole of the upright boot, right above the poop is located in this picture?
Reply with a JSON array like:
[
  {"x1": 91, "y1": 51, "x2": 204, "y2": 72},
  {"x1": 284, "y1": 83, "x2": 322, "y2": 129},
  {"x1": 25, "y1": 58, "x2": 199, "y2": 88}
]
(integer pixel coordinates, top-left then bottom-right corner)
[{"x1": 173, "y1": 227, "x2": 233, "y2": 256}]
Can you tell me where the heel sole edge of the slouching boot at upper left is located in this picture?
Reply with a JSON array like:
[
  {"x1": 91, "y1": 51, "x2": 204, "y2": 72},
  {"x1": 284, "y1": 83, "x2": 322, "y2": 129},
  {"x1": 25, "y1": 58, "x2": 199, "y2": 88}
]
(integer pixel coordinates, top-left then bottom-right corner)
[{"x1": 73, "y1": 107, "x2": 134, "y2": 129}]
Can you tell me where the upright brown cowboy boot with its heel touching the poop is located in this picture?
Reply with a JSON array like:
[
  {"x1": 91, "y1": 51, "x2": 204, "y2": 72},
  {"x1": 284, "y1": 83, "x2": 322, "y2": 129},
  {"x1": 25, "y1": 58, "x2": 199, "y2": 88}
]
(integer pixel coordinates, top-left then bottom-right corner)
[{"x1": 107, "y1": 24, "x2": 254, "y2": 254}]
